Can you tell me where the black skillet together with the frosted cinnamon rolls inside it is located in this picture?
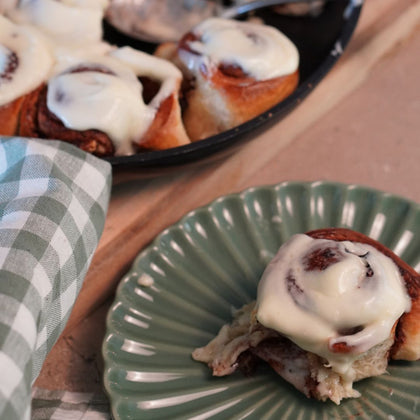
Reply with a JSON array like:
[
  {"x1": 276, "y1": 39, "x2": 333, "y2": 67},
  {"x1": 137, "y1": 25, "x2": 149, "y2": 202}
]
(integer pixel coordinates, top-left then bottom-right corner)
[{"x1": 0, "y1": 0, "x2": 361, "y2": 168}]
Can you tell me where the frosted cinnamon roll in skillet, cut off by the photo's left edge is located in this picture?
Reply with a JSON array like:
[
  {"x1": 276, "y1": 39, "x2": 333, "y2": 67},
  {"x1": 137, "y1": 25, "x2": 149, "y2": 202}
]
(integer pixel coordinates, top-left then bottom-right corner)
[{"x1": 0, "y1": 15, "x2": 54, "y2": 135}]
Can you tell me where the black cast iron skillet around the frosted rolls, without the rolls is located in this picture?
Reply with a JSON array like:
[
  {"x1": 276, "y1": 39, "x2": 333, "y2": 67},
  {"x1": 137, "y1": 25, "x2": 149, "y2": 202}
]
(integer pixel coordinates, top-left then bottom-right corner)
[{"x1": 104, "y1": 0, "x2": 363, "y2": 171}]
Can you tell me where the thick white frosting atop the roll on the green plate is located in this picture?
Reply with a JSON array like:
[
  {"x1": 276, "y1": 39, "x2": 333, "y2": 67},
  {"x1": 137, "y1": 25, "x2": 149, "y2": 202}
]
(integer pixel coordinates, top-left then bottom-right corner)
[{"x1": 257, "y1": 234, "x2": 411, "y2": 384}]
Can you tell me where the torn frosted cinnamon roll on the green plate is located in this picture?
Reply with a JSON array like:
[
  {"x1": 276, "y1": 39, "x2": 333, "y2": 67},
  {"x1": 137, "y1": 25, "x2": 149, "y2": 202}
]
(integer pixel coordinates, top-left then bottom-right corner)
[{"x1": 193, "y1": 229, "x2": 420, "y2": 404}]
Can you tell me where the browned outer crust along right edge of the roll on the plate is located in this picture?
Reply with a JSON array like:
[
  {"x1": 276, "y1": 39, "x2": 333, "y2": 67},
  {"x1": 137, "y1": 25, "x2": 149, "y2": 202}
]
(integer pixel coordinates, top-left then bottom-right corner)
[{"x1": 306, "y1": 228, "x2": 420, "y2": 360}]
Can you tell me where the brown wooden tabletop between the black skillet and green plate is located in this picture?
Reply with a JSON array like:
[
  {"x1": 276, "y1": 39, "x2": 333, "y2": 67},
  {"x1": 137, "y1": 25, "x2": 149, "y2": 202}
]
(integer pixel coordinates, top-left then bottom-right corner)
[{"x1": 35, "y1": 0, "x2": 420, "y2": 391}]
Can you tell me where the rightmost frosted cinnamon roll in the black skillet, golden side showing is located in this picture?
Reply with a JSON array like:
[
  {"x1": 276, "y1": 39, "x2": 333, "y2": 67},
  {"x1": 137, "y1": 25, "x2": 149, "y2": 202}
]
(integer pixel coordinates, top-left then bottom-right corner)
[{"x1": 157, "y1": 18, "x2": 299, "y2": 140}]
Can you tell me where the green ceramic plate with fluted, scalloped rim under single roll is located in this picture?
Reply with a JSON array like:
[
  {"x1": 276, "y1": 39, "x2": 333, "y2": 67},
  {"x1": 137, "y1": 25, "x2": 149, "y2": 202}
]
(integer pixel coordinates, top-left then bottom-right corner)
[{"x1": 103, "y1": 182, "x2": 420, "y2": 420}]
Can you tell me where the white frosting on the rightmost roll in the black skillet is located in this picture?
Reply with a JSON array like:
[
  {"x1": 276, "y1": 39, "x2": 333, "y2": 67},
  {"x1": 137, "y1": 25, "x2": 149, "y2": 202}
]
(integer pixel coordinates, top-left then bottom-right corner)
[{"x1": 180, "y1": 18, "x2": 299, "y2": 80}]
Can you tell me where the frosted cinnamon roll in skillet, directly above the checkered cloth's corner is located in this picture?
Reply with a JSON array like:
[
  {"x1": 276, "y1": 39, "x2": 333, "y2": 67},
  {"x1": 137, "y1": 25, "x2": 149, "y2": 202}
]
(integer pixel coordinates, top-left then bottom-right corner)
[{"x1": 19, "y1": 47, "x2": 189, "y2": 156}]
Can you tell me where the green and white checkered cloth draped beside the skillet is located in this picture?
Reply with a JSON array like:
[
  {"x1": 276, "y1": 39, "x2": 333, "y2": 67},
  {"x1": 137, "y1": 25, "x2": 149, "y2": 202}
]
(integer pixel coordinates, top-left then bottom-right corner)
[{"x1": 0, "y1": 137, "x2": 111, "y2": 420}]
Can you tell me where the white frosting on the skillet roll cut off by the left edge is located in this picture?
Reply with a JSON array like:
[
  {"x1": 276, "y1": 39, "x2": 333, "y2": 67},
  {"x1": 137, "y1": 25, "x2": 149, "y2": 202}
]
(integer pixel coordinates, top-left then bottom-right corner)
[{"x1": 0, "y1": 15, "x2": 54, "y2": 106}]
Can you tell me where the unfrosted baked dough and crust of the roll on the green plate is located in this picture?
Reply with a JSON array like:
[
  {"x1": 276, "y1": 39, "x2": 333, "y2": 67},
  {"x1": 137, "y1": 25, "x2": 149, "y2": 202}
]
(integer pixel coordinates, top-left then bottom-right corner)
[{"x1": 192, "y1": 228, "x2": 420, "y2": 404}]
